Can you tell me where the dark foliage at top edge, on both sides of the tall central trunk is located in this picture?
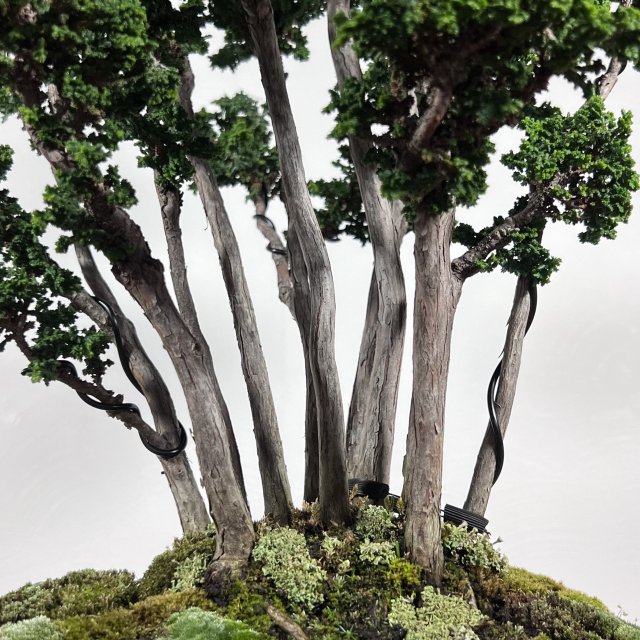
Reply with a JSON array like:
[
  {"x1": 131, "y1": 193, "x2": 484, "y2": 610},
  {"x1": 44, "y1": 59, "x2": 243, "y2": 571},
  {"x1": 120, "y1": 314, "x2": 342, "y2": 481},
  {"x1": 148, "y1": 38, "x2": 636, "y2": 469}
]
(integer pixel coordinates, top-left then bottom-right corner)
[{"x1": 209, "y1": 0, "x2": 325, "y2": 69}]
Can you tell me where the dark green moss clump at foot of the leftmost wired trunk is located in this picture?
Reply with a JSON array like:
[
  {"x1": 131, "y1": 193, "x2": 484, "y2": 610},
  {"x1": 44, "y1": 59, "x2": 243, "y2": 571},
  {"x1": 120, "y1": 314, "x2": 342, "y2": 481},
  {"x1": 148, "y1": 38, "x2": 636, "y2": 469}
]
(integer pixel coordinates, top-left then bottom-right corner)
[{"x1": 138, "y1": 527, "x2": 216, "y2": 598}]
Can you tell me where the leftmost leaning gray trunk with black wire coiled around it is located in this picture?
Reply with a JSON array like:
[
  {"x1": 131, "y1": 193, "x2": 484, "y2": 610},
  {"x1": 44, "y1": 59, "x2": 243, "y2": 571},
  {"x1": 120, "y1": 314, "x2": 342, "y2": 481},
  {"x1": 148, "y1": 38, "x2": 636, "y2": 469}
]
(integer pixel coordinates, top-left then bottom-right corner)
[{"x1": 75, "y1": 245, "x2": 211, "y2": 533}]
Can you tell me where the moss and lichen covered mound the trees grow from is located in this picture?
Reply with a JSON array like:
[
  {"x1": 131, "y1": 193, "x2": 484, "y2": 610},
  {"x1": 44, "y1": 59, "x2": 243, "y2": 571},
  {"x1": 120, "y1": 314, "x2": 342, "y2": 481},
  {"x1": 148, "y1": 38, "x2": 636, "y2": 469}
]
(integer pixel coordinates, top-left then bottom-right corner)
[{"x1": 0, "y1": 505, "x2": 640, "y2": 640}]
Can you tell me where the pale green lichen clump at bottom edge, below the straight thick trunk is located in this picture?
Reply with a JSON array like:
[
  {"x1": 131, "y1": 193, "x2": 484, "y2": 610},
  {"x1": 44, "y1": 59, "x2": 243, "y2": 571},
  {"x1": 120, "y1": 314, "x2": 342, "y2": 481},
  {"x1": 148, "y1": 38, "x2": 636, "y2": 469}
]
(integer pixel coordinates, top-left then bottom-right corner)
[{"x1": 389, "y1": 587, "x2": 483, "y2": 640}]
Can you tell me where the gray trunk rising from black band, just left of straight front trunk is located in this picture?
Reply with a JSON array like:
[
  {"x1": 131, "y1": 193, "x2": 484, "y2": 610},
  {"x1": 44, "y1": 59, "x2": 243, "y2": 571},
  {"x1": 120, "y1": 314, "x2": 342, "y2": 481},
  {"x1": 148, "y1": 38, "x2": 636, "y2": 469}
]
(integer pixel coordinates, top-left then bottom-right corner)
[{"x1": 327, "y1": 0, "x2": 407, "y2": 483}]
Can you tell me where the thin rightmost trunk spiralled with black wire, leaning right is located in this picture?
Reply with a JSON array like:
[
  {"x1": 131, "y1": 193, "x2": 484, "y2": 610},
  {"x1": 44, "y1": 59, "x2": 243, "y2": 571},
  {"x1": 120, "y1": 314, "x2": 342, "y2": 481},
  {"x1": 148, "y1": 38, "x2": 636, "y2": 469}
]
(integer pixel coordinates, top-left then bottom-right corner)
[{"x1": 464, "y1": 277, "x2": 531, "y2": 516}]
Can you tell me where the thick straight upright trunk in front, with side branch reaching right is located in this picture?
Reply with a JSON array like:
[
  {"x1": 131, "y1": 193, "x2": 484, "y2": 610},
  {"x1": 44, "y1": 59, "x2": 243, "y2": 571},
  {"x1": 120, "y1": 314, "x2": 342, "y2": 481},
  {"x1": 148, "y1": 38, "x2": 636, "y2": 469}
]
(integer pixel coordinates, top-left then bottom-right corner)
[{"x1": 403, "y1": 211, "x2": 461, "y2": 585}]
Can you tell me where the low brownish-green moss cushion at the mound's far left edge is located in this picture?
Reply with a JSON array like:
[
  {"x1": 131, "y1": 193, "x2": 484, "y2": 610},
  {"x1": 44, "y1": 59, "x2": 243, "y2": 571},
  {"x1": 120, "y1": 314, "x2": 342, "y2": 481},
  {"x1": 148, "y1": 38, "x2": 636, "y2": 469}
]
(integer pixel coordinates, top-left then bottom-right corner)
[{"x1": 0, "y1": 569, "x2": 138, "y2": 623}]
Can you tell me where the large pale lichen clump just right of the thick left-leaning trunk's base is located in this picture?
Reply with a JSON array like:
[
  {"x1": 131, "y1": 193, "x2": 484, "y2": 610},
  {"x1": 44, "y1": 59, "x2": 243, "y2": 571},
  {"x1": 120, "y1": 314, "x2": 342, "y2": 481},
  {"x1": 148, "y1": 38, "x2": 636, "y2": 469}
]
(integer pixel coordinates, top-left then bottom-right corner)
[{"x1": 252, "y1": 527, "x2": 327, "y2": 610}]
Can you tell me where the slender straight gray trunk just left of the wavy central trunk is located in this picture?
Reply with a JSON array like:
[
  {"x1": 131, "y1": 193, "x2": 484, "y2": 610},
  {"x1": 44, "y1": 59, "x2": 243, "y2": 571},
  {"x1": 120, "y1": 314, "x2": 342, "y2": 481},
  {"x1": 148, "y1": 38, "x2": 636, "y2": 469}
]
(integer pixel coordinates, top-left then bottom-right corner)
[{"x1": 180, "y1": 57, "x2": 293, "y2": 524}]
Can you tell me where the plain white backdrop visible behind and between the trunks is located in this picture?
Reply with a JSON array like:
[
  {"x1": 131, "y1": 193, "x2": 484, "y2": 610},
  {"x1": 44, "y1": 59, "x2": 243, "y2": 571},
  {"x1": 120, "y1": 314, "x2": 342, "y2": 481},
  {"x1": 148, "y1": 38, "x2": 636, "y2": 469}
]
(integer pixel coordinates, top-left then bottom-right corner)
[{"x1": 0, "y1": 22, "x2": 640, "y2": 619}]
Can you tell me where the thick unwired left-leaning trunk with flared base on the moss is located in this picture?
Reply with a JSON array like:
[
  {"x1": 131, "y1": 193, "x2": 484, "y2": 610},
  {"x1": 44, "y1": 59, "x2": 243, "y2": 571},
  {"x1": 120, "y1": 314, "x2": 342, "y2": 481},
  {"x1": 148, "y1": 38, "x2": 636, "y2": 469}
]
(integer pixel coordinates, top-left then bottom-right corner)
[{"x1": 20, "y1": 99, "x2": 255, "y2": 569}]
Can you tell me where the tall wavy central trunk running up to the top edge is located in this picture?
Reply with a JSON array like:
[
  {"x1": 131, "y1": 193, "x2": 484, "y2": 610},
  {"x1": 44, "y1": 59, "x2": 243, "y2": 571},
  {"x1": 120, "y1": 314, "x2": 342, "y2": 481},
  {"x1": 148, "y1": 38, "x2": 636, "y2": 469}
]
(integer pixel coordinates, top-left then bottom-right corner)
[{"x1": 242, "y1": 0, "x2": 349, "y2": 524}]
